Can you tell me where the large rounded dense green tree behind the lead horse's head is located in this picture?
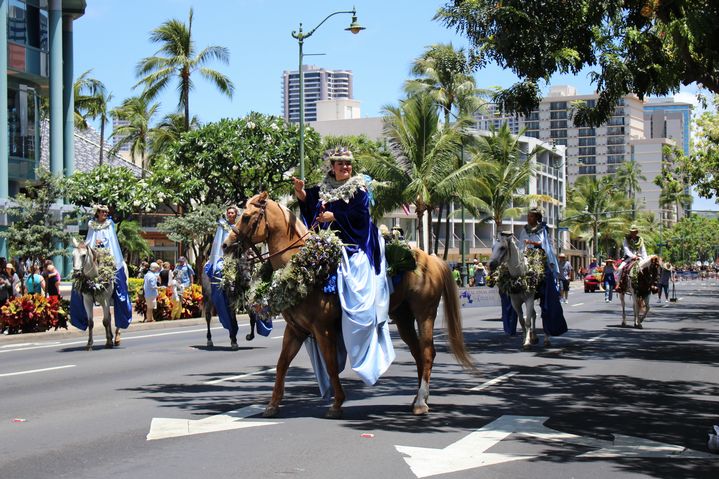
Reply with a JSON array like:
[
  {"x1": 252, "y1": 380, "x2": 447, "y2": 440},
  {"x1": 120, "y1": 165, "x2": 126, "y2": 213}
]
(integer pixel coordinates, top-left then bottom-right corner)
[{"x1": 152, "y1": 113, "x2": 321, "y2": 210}]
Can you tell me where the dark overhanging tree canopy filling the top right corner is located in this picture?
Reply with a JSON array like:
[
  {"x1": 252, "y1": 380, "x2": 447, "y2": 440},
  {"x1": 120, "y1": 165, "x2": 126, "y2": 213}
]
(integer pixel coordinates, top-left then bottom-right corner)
[{"x1": 435, "y1": 0, "x2": 719, "y2": 126}]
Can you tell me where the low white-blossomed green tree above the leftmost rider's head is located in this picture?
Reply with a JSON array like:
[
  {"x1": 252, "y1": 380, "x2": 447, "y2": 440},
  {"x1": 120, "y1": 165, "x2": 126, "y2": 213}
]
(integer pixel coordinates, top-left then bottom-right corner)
[{"x1": 64, "y1": 164, "x2": 160, "y2": 224}]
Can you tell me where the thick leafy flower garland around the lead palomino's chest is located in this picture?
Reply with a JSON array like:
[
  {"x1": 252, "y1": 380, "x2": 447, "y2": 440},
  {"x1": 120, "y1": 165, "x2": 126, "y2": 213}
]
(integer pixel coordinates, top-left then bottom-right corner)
[{"x1": 247, "y1": 230, "x2": 343, "y2": 319}]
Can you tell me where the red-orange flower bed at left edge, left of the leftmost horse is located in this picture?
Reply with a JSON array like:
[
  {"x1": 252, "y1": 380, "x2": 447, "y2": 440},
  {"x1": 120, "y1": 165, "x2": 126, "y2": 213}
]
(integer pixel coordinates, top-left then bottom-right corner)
[{"x1": 0, "y1": 294, "x2": 70, "y2": 334}]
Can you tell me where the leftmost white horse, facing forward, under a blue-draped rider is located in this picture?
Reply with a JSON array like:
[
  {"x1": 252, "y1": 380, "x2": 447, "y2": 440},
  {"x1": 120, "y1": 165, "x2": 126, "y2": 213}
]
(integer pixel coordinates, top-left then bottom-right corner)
[{"x1": 72, "y1": 240, "x2": 120, "y2": 351}]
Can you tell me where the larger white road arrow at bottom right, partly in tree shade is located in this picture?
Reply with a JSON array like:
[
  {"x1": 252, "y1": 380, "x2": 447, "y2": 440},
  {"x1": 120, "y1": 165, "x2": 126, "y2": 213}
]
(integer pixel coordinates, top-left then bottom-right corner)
[{"x1": 395, "y1": 416, "x2": 716, "y2": 477}]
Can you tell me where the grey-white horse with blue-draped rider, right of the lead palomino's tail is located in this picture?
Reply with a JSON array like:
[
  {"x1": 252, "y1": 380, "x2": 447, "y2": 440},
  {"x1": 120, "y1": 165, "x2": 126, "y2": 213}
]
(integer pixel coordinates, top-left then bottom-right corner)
[{"x1": 489, "y1": 233, "x2": 551, "y2": 349}]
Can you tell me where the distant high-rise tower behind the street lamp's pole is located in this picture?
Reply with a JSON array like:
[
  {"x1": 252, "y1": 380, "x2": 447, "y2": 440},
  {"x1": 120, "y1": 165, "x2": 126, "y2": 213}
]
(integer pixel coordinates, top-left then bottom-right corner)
[{"x1": 282, "y1": 65, "x2": 353, "y2": 123}]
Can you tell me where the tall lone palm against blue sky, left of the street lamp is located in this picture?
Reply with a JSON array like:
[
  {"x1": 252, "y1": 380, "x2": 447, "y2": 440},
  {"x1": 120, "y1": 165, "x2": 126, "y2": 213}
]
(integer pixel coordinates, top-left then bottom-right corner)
[{"x1": 135, "y1": 8, "x2": 235, "y2": 131}]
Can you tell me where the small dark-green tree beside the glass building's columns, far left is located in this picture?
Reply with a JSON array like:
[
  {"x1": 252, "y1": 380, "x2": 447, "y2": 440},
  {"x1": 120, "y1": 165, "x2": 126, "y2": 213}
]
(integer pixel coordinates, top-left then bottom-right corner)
[{"x1": 0, "y1": 168, "x2": 71, "y2": 263}]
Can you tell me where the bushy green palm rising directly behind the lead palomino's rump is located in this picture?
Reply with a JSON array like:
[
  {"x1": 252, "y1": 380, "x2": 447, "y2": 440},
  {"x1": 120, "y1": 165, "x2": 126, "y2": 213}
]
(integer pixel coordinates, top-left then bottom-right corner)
[{"x1": 366, "y1": 93, "x2": 460, "y2": 251}]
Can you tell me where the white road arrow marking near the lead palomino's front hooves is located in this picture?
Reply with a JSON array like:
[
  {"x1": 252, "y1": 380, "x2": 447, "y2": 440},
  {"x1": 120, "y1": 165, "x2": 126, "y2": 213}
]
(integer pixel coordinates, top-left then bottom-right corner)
[{"x1": 147, "y1": 405, "x2": 280, "y2": 441}]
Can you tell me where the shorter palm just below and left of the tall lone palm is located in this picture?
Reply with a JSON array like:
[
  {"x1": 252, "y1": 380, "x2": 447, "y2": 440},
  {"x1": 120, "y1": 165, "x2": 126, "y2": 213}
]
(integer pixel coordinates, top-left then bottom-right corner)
[{"x1": 111, "y1": 96, "x2": 160, "y2": 178}]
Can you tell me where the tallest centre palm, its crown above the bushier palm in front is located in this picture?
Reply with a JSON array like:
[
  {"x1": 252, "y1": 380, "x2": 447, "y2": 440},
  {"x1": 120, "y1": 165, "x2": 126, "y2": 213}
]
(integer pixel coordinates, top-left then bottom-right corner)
[{"x1": 405, "y1": 43, "x2": 479, "y2": 259}]
